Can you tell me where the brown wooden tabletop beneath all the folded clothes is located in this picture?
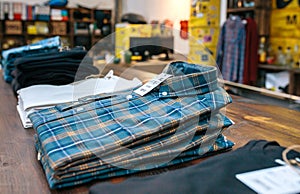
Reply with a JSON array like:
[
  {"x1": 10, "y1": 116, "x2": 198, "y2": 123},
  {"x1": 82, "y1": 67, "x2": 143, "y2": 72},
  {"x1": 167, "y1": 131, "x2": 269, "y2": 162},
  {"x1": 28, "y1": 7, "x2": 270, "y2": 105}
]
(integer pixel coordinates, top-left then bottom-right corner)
[{"x1": 0, "y1": 65, "x2": 300, "y2": 194}]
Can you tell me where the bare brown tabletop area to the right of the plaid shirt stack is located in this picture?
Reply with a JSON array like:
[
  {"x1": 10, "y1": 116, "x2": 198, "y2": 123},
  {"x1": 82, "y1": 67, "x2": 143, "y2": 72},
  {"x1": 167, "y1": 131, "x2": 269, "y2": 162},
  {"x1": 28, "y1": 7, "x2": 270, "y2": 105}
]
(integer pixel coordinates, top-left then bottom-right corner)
[{"x1": 224, "y1": 96, "x2": 300, "y2": 147}]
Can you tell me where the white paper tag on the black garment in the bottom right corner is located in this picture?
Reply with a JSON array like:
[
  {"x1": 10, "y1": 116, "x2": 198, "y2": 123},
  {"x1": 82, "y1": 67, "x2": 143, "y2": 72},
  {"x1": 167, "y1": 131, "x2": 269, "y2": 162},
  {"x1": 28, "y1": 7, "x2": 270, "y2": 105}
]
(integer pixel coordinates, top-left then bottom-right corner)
[{"x1": 236, "y1": 165, "x2": 300, "y2": 194}]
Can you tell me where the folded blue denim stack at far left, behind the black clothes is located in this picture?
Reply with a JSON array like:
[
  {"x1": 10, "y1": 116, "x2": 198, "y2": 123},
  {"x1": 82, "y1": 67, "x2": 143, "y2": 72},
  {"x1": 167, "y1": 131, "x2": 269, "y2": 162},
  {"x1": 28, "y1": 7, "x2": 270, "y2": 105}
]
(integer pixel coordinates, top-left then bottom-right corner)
[{"x1": 2, "y1": 36, "x2": 61, "y2": 83}]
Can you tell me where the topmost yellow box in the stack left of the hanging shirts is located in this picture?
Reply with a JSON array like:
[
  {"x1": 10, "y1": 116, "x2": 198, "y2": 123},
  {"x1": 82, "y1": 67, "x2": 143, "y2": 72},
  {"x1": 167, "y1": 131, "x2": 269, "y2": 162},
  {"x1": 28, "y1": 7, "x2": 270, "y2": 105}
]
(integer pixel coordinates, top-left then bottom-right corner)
[{"x1": 189, "y1": 0, "x2": 220, "y2": 27}]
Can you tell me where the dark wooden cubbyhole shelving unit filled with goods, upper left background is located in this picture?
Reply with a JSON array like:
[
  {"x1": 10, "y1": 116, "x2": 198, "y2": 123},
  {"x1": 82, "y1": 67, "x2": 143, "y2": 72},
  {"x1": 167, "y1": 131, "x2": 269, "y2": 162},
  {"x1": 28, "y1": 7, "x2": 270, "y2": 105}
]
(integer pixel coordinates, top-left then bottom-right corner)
[{"x1": 0, "y1": 7, "x2": 112, "y2": 52}]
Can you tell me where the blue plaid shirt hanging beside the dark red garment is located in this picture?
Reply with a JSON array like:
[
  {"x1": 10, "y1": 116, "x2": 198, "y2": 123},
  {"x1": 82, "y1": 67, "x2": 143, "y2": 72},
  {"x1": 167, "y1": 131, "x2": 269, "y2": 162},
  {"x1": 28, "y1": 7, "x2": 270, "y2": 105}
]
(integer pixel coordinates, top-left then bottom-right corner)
[{"x1": 217, "y1": 16, "x2": 246, "y2": 83}]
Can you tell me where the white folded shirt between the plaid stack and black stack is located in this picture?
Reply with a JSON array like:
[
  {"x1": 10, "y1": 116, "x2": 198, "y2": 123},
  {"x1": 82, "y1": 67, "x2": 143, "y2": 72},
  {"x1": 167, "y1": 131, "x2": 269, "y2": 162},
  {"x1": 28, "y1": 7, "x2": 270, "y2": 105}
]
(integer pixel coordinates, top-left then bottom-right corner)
[{"x1": 17, "y1": 70, "x2": 142, "y2": 128}]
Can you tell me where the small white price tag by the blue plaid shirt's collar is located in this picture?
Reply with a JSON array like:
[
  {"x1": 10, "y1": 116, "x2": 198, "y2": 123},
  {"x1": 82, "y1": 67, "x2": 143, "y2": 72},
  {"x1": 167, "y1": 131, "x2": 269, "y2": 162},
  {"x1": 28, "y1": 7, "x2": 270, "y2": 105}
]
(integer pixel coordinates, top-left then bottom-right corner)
[{"x1": 134, "y1": 73, "x2": 172, "y2": 96}]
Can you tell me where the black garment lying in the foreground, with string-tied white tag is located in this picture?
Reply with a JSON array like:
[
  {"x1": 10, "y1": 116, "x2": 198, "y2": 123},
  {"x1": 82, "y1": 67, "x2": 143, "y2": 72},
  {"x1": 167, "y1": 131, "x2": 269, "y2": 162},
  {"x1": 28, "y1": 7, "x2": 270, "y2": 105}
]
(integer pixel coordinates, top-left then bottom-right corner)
[{"x1": 89, "y1": 140, "x2": 299, "y2": 194}]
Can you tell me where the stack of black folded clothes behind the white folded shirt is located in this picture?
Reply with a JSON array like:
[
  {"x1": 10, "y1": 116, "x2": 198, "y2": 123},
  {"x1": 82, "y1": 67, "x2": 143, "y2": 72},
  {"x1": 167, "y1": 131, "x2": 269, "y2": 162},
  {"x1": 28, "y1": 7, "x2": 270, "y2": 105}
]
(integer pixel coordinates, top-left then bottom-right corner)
[{"x1": 12, "y1": 47, "x2": 99, "y2": 93}]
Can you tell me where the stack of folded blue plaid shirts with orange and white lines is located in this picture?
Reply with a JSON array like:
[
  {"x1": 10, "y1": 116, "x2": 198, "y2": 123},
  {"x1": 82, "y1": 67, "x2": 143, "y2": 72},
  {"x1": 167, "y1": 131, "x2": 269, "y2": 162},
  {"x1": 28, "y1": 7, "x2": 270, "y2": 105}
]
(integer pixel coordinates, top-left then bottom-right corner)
[{"x1": 29, "y1": 62, "x2": 234, "y2": 188}]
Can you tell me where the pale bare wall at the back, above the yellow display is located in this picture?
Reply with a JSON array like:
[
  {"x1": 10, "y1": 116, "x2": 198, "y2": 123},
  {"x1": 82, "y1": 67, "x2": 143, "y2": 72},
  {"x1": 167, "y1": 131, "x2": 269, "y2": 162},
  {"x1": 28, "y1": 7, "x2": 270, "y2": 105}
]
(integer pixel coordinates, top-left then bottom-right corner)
[{"x1": 122, "y1": 0, "x2": 190, "y2": 54}]
